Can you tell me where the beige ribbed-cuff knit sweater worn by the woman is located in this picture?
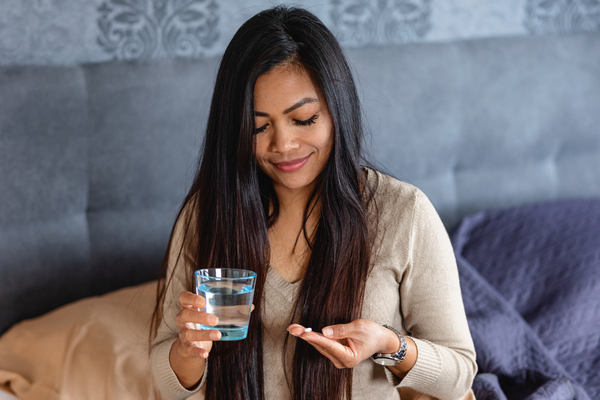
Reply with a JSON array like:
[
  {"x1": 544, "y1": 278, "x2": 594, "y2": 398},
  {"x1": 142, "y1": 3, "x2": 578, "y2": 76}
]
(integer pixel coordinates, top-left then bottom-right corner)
[{"x1": 151, "y1": 170, "x2": 477, "y2": 400}]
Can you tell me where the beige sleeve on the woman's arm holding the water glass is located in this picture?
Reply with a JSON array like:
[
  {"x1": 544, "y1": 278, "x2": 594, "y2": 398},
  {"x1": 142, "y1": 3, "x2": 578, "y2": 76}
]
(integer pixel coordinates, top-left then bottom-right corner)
[{"x1": 150, "y1": 208, "x2": 208, "y2": 400}]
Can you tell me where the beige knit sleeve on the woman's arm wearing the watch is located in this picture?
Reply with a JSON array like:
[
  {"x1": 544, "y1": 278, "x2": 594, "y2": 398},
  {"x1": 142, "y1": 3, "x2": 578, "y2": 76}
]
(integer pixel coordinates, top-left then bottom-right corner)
[{"x1": 386, "y1": 190, "x2": 477, "y2": 400}]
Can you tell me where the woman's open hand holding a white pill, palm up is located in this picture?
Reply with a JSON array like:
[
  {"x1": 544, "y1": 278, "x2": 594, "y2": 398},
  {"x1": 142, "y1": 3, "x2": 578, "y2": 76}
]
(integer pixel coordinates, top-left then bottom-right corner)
[{"x1": 288, "y1": 319, "x2": 400, "y2": 368}]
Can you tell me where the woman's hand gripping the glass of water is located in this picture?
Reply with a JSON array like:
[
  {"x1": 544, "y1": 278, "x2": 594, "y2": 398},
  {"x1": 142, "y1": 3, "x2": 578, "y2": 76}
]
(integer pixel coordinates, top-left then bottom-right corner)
[{"x1": 175, "y1": 291, "x2": 221, "y2": 359}]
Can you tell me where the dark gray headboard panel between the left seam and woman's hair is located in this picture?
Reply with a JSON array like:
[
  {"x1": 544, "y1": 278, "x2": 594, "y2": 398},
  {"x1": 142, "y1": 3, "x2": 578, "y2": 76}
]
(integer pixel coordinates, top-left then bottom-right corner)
[{"x1": 85, "y1": 59, "x2": 217, "y2": 292}]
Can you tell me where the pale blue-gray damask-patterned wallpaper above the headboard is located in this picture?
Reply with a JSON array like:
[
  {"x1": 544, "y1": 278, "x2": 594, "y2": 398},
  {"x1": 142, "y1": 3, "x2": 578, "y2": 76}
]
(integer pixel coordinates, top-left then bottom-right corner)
[{"x1": 0, "y1": 0, "x2": 600, "y2": 65}]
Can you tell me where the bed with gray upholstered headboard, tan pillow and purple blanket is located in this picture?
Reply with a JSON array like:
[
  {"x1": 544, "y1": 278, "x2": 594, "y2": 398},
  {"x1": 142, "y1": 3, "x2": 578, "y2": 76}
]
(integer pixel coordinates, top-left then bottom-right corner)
[{"x1": 0, "y1": 34, "x2": 600, "y2": 400}]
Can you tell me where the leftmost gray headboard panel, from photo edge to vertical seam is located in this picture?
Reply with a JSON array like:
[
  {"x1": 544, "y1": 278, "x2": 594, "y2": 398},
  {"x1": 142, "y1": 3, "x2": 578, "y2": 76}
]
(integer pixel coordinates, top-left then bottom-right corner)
[{"x1": 0, "y1": 67, "x2": 90, "y2": 332}]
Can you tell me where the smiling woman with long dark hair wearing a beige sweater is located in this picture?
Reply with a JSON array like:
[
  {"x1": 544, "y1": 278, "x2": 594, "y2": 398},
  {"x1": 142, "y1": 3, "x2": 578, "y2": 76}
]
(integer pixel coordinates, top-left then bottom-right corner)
[{"x1": 152, "y1": 3, "x2": 476, "y2": 399}]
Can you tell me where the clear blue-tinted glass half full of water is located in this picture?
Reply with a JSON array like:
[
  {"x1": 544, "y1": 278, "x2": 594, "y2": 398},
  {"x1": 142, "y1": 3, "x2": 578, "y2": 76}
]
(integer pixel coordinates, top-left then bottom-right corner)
[{"x1": 194, "y1": 268, "x2": 256, "y2": 340}]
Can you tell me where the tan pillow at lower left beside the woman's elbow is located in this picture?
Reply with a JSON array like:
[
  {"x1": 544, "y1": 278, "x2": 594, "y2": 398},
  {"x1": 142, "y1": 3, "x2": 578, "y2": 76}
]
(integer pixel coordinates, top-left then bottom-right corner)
[{"x1": 0, "y1": 281, "x2": 182, "y2": 400}]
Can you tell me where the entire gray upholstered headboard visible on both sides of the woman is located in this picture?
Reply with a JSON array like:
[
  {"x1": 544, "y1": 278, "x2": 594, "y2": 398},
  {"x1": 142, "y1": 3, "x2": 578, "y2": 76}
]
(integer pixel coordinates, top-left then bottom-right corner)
[{"x1": 0, "y1": 34, "x2": 600, "y2": 332}]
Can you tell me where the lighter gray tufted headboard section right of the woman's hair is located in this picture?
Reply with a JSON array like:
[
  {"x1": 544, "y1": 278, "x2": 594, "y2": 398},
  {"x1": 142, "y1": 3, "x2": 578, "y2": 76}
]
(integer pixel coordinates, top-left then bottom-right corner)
[{"x1": 350, "y1": 35, "x2": 600, "y2": 226}]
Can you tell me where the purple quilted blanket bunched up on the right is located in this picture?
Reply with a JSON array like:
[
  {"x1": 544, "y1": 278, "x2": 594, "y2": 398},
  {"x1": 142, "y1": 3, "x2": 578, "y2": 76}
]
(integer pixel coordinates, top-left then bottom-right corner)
[{"x1": 451, "y1": 199, "x2": 600, "y2": 400}]
